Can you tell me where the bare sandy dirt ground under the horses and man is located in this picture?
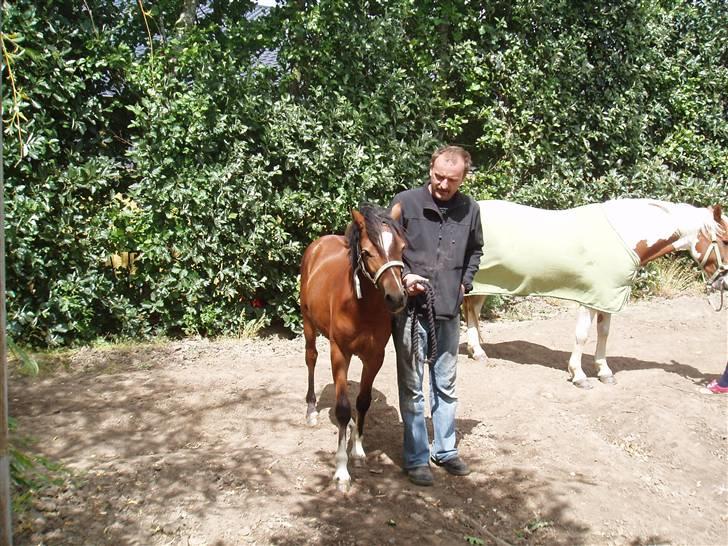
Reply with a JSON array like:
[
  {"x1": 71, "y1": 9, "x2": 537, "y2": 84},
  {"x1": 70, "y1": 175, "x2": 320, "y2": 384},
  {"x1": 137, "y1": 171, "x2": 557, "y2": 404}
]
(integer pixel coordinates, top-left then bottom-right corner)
[{"x1": 10, "y1": 296, "x2": 728, "y2": 546}]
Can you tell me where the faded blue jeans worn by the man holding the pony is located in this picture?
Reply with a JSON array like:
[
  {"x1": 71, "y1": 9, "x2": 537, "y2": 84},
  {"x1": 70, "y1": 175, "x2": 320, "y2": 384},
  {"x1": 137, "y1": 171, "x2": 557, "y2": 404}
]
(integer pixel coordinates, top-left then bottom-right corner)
[{"x1": 392, "y1": 312, "x2": 460, "y2": 469}]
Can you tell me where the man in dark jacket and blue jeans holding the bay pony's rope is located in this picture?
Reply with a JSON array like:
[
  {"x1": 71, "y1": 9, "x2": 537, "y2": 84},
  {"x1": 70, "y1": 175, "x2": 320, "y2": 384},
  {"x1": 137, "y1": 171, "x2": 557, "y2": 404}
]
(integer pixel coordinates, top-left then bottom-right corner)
[{"x1": 390, "y1": 146, "x2": 483, "y2": 486}]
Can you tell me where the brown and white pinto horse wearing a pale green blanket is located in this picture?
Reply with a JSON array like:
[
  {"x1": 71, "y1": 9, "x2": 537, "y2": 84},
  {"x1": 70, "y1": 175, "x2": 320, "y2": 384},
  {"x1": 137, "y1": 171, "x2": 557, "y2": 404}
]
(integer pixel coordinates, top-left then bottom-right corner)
[{"x1": 463, "y1": 199, "x2": 728, "y2": 388}]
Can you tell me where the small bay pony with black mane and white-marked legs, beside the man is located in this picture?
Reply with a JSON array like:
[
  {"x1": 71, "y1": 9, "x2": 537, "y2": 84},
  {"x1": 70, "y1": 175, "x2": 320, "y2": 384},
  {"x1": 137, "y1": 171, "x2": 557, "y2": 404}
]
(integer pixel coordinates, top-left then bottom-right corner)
[{"x1": 301, "y1": 205, "x2": 407, "y2": 491}]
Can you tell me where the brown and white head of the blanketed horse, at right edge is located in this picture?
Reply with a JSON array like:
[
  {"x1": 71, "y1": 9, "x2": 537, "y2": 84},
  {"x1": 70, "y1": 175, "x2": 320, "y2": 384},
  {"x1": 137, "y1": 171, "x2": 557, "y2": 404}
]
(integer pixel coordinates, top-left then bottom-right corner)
[{"x1": 695, "y1": 205, "x2": 728, "y2": 290}]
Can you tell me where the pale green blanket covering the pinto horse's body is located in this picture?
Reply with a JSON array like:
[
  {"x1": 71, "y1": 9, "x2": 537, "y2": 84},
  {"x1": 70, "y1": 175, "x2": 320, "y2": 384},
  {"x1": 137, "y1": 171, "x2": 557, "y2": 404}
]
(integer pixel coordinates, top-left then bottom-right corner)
[{"x1": 471, "y1": 200, "x2": 639, "y2": 313}]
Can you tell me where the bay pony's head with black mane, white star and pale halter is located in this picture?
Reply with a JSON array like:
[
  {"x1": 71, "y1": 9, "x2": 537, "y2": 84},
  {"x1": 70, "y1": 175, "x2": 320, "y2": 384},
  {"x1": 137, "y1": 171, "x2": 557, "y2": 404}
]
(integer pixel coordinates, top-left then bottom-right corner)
[{"x1": 346, "y1": 204, "x2": 407, "y2": 313}]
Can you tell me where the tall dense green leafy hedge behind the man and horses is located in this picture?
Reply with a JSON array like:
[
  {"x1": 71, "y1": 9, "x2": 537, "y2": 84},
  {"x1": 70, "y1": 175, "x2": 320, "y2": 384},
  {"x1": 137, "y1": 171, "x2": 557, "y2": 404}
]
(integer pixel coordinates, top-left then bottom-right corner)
[{"x1": 2, "y1": 0, "x2": 728, "y2": 346}]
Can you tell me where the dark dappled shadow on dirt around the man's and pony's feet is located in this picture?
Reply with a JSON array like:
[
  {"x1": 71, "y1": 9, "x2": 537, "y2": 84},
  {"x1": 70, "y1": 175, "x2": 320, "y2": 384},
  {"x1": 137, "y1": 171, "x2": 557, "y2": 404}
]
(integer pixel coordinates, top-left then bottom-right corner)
[{"x1": 292, "y1": 381, "x2": 600, "y2": 546}]
